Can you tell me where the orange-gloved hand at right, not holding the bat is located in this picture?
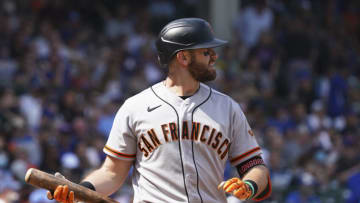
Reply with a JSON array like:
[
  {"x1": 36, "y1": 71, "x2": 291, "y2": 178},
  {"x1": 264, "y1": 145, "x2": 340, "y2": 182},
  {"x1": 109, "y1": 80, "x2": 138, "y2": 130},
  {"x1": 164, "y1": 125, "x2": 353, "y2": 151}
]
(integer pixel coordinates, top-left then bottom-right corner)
[{"x1": 218, "y1": 178, "x2": 252, "y2": 200}]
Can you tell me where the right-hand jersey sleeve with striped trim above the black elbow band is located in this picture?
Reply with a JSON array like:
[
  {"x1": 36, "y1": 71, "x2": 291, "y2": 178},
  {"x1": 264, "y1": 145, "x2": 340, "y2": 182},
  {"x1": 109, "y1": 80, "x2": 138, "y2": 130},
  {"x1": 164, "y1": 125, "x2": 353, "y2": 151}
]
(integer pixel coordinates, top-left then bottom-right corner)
[{"x1": 229, "y1": 103, "x2": 262, "y2": 166}]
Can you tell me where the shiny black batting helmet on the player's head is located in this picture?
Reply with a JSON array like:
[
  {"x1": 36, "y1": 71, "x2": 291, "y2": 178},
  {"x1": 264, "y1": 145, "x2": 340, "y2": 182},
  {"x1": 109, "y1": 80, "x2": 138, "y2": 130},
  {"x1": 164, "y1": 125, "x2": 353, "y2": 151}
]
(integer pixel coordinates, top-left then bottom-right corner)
[{"x1": 156, "y1": 18, "x2": 227, "y2": 65}]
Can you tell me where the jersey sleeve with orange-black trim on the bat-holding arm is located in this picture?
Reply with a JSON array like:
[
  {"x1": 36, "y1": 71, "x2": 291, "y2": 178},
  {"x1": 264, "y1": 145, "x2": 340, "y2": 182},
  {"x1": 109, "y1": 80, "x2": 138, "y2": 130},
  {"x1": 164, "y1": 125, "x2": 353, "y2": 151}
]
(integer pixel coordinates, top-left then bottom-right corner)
[{"x1": 103, "y1": 102, "x2": 137, "y2": 160}]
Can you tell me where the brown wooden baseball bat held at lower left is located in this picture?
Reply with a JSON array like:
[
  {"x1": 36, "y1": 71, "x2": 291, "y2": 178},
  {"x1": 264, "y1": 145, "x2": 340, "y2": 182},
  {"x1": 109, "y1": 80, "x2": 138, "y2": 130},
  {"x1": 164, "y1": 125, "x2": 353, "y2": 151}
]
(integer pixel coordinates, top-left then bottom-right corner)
[{"x1": 25, "y1": 168, "x2": 119, "y2": 203}]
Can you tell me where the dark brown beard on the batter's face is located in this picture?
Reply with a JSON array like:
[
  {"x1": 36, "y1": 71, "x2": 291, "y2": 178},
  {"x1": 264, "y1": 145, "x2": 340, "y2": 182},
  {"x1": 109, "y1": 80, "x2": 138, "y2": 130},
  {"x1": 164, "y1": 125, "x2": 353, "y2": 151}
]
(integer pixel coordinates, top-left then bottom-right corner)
[{"x1": 188, "y1": 56, "x2": 216, "y2": 82}]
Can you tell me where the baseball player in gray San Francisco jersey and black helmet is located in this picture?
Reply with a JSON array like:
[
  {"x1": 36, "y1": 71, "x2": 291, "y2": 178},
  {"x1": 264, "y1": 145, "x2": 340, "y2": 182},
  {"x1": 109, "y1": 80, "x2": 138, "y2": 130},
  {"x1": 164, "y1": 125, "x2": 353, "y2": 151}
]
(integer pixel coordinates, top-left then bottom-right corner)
[{"x1": 48, "y1": 18, "x2": 271, "y2": 203}]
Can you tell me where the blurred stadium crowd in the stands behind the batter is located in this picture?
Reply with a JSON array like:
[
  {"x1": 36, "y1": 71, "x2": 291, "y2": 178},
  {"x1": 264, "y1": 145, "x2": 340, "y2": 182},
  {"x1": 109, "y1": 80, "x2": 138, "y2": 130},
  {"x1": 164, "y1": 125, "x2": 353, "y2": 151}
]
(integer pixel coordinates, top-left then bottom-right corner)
[{"x1": 0, "y1": 0, "x2": 360, "y2": 203}]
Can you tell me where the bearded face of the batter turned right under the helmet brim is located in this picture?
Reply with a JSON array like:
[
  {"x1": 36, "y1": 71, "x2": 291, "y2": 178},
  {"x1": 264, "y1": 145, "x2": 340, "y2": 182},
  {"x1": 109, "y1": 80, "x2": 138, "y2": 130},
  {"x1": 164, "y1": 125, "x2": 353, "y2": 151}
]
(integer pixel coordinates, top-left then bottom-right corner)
[{"x1": 189, "y1": 48, "x2": 217, "y2": 82}]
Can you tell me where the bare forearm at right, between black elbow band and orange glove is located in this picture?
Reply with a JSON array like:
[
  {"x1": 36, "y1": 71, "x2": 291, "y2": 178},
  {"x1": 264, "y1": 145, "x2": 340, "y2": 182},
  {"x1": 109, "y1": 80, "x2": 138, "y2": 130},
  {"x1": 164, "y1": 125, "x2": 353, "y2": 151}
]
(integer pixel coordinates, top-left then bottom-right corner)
[{"x1": 242, "y1": 165, "x2": 269, "y2": 197}]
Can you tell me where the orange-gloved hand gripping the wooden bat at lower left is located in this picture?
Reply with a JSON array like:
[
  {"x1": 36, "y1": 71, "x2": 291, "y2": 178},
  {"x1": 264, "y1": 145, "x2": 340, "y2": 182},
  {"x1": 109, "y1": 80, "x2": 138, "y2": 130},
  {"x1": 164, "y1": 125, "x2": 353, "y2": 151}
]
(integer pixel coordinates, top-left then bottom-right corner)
[{"x1": 47, "y1": 172, "x2": 75, "y2": 203}]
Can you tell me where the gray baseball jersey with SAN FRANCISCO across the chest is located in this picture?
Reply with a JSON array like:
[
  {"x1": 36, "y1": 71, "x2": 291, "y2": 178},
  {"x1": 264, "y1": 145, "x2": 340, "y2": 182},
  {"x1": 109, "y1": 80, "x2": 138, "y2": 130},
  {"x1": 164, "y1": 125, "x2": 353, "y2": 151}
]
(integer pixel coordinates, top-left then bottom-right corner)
[{"x1": 104, "y1": 82, "x2": 261, "y2": 203}]
